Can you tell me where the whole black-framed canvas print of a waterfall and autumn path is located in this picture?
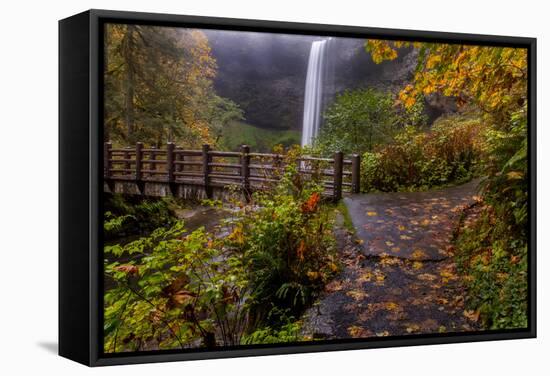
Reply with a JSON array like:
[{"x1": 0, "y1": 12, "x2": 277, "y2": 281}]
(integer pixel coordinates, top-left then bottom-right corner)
[{"x1": 59, "y1": 10, "x2": 536, "y2": 366}]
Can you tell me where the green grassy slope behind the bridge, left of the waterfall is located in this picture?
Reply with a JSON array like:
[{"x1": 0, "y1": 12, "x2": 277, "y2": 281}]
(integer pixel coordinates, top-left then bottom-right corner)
[{"x1": 220, "y1": 121, "x2": 300, "y2": 152}]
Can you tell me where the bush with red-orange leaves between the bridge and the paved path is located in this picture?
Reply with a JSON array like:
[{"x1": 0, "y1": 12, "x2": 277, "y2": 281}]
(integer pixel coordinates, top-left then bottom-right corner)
[{"x1": 231, "y1": 148, "x2": 338, "y2": 313}]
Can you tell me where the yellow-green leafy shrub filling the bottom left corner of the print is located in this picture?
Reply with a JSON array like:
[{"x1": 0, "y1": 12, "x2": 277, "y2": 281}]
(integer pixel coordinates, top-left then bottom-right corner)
[{"x1": 103, "y1": 222, "x2": 250, "y2": 352}]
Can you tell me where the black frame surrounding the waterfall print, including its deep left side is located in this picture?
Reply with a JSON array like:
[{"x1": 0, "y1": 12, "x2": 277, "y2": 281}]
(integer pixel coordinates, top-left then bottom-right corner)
[{"x1": 59, "y1": 10, "x2": 536, "y2": 366}]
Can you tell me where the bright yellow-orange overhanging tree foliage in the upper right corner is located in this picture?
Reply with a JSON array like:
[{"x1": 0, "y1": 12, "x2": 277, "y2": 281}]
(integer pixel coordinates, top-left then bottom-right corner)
[{"x1": 365, "y1": 40, "x2": 527, "y2": 127}]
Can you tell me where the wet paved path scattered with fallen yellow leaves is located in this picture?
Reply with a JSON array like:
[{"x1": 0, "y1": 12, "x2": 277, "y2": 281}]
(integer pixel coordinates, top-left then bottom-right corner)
[{"x1": 303, "y1": 181, "x2": 484, "y2": 339}]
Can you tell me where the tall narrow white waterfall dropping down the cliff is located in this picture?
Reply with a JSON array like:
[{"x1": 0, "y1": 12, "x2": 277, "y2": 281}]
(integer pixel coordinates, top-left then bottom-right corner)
[{"x1": 302, "y1": 40, "x2": 327, "y2": 146}]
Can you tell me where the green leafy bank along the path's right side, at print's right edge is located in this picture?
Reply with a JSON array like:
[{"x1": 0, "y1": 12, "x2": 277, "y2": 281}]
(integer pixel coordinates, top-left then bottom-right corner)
[{"x1": 456, "y1": 109, "x2": 528, "y2": 329}]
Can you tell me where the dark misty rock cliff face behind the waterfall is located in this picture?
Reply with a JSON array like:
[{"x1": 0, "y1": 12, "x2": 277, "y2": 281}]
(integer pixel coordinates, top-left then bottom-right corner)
[{"x1": 205, "y1": 30, "x2": 440, "y2": 130}]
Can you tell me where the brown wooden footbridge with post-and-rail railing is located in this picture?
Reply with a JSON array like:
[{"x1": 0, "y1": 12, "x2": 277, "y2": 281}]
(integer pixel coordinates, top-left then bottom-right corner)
[{"x1": 103, "y1": 142, "x2": 361, "y2": 200}]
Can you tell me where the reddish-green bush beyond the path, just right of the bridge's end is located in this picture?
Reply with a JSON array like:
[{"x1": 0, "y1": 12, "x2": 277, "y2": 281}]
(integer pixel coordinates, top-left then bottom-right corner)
[{"x1": 361, "y1": 115, "x2": 483, "y2": 192}]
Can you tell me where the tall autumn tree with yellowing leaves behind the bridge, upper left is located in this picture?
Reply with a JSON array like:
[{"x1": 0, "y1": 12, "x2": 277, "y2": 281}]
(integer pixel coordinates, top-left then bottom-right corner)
[{"x1": 104, "y1": 24, "x2": 242, "y2": 146}]
